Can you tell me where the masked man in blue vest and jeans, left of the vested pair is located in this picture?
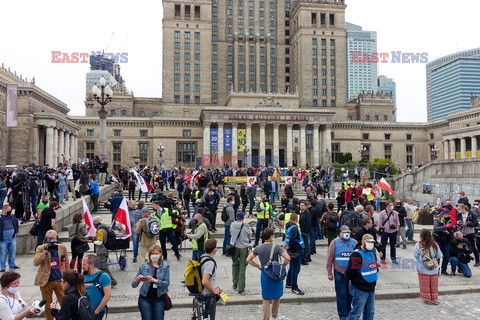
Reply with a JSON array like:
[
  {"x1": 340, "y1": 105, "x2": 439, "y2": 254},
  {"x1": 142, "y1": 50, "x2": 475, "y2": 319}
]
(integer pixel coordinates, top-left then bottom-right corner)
[{"x1": 327, "y1": 225, "x2": 357, "y2": 320}]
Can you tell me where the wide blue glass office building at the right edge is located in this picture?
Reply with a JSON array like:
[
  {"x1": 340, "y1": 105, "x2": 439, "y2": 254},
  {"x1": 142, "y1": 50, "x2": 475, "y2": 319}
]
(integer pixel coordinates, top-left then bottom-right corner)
[{"x1": 427, "y1": 48, "x2": 480, "y2": 121}]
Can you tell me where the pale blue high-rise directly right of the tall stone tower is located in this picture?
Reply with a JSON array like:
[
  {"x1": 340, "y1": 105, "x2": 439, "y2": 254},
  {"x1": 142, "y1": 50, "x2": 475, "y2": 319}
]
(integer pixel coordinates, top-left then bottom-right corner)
[{"x1": 346, "y1": 22, "x2": 378, "y2": 100}]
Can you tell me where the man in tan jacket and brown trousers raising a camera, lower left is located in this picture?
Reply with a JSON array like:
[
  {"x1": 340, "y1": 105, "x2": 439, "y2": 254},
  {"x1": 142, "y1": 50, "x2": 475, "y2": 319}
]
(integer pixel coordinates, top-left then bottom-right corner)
[{"x1": 33, "y1": 230, "x2": 68, "y2": 320}]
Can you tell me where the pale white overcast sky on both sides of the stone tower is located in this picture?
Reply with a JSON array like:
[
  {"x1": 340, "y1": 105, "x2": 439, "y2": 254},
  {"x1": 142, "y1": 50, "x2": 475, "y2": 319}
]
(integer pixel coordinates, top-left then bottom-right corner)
[{"x1": 0, "y1": 0, "x2": 480, "y2": 122}]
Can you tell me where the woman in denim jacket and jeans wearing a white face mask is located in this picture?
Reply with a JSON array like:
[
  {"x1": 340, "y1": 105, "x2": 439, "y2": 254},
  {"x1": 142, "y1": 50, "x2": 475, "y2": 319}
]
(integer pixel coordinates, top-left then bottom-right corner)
[{"x1": 132, "y1": 245, "x2": 170, "y2": 320}]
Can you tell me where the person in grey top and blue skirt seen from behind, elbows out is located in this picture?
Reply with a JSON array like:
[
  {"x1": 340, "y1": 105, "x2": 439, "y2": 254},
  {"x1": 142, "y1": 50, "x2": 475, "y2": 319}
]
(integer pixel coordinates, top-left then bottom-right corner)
[{"x1": 247, "y1": 228, "x2": 290, "y2": 320}]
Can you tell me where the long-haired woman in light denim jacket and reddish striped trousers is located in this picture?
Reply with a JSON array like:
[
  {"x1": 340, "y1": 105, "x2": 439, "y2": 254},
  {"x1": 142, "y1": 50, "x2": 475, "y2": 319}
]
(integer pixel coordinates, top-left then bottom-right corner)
[{"x1": 413, "y1": 229, "x2": 443, "y2": 305}]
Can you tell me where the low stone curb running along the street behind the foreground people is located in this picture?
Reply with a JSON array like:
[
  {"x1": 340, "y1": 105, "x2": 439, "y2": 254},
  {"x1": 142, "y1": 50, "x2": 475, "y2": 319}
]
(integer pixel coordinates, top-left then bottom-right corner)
[{"x1": 108, "y1": 285, "x2": 480, "y2": 313}]
